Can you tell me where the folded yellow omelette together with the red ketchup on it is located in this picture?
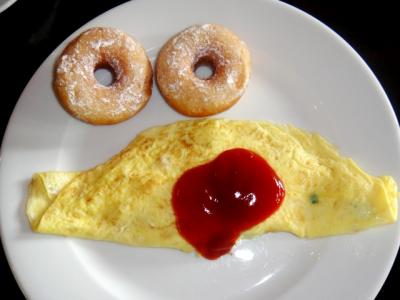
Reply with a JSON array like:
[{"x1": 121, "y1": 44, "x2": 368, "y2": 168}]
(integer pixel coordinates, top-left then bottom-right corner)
[{"x1": 26, "y1": 119, "x2": 397, "y2": 259}]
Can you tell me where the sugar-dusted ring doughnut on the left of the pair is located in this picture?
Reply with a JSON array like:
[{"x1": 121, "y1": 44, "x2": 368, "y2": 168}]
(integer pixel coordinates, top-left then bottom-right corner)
[{"x1": 53, "y1": 27, "x2": 153, "y2": 125}]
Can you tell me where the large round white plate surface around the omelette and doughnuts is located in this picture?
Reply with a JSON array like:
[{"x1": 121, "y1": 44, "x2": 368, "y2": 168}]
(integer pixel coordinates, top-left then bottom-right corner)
[{"x1": 0, "y1": 0, "x2": 400, "y2": 299}]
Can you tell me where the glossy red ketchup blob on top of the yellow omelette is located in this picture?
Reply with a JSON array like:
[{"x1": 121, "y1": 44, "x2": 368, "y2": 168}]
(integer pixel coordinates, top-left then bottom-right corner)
[{"x1": 172, "y1": 148, "x2": 285, "y2": 259}]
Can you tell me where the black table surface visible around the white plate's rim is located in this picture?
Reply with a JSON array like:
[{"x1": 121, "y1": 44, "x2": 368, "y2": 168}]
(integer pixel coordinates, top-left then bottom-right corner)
[{"x1": 0, "y1": 0, "x2": 400, "y2": 299}]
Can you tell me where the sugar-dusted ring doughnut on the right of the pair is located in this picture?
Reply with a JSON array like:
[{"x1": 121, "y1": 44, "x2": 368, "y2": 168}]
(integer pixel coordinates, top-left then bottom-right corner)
[{"x1": 156, "y1": 24, "x2": 250, "y2": 117}]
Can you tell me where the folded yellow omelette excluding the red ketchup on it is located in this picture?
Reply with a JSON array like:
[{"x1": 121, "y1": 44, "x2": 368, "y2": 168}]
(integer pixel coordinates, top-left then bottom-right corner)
[{"x1": 26, "y1": 119, "x2": 398, "y2": 252}]
